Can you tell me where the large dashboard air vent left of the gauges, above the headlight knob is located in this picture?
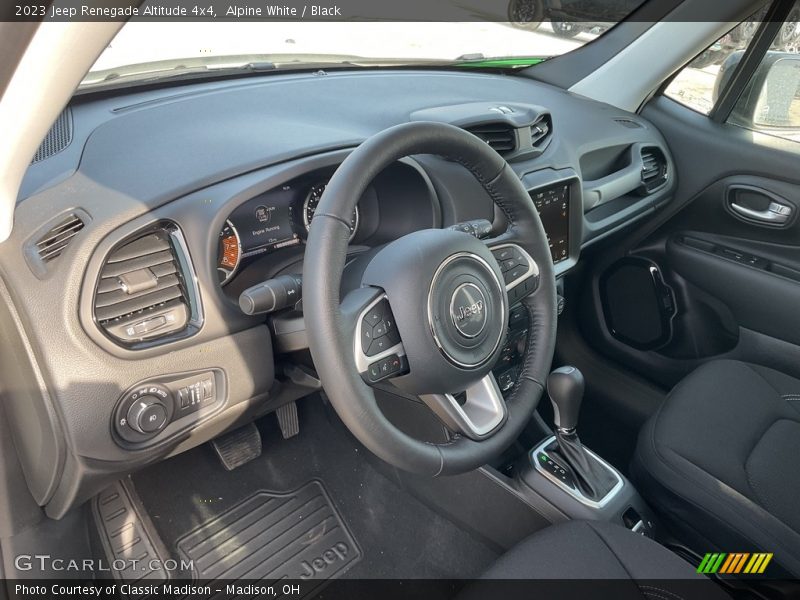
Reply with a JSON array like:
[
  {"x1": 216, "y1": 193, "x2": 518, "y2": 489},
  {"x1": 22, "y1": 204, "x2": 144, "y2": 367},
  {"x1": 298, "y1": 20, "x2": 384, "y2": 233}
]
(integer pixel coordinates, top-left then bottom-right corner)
[{"x1": 94, "y1": 224, "x2": 200, "y2": 345}]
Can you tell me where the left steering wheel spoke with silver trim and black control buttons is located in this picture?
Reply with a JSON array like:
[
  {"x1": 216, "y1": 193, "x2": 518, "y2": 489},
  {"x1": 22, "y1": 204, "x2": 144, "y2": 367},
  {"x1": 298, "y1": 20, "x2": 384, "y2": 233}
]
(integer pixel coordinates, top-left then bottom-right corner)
[{"x1": 342, "y1": 287, "x2": 408, "y2": 385}]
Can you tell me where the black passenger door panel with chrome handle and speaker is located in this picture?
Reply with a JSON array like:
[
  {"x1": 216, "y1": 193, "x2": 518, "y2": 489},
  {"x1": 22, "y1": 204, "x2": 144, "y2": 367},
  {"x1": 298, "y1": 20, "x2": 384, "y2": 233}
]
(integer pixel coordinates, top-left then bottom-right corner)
[{"x1": 581, "y1": 98, "x2": 800, "y2": 387}]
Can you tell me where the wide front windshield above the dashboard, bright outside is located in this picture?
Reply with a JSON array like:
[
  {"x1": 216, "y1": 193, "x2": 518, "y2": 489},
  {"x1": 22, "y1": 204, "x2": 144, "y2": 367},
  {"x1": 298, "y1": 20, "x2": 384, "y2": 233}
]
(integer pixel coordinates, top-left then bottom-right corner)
[{"x1": 82, "y1": 12, "x2": 644, "y2": 87}]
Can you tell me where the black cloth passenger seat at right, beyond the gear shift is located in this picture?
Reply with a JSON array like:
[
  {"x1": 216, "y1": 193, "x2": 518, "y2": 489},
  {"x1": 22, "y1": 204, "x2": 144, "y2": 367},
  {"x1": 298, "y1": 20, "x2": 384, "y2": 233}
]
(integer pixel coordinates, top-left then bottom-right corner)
[{"x1": 631, "y1": 360, "x2": 800, "y2": 577}]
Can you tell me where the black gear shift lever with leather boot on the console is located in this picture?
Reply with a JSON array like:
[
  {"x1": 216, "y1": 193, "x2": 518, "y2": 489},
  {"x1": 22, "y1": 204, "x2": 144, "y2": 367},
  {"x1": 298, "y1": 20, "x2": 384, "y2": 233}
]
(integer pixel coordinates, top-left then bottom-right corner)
[{"x1": 547, "y1": 367, "x2": 616, "y2": 501}]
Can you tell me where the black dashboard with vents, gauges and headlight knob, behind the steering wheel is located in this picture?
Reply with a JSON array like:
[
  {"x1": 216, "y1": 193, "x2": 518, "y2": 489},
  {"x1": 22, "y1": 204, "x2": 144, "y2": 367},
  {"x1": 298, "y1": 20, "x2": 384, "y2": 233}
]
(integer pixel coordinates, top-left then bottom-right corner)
[{"x1": 0, "y1": 70, "x2": 675, "y2": 517}]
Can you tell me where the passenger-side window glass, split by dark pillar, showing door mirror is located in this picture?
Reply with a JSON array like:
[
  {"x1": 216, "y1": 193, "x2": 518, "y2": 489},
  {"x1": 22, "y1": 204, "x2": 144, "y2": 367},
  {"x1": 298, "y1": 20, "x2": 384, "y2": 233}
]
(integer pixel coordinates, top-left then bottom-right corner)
[{"x1": 664, "y1": 0, "x2": 800, "y2": 142}]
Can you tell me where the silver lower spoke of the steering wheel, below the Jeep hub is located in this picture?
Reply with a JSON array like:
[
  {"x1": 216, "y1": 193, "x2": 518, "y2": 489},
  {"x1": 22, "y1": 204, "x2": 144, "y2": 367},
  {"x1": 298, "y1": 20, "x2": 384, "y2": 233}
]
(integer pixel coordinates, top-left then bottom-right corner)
[{"x1": 420, "y1": 373, "x2": 507, "y2": 440}]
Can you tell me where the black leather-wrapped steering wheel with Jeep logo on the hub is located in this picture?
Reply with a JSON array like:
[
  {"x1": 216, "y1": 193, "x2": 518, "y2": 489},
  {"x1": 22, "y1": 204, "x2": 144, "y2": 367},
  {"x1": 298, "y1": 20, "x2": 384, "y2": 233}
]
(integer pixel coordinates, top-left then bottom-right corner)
[{"x1": 303, "y1": 122, "x2": 557, "y2": 475}]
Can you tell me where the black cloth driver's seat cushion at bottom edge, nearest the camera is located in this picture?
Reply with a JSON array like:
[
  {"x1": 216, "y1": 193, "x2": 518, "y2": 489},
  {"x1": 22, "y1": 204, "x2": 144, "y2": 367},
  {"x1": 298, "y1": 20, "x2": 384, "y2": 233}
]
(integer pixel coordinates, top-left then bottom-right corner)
[{"x1": 459, "y1": 521, "x2": 729, "y2": 600}]
